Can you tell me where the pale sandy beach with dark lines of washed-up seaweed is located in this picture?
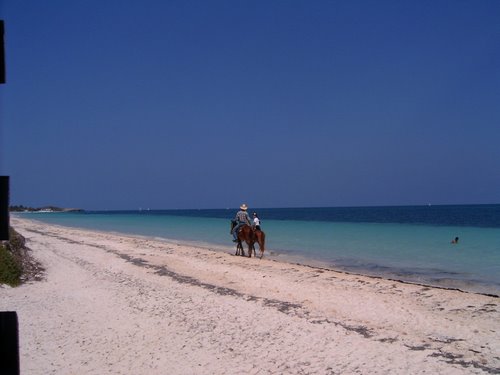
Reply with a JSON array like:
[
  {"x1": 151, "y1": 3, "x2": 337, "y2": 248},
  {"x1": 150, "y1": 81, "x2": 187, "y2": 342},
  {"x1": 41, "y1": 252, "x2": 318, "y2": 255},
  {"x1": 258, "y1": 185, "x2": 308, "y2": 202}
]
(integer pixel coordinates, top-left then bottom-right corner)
[{"x1": 0, "y1": 217, "x2": 500, "y2": 374}]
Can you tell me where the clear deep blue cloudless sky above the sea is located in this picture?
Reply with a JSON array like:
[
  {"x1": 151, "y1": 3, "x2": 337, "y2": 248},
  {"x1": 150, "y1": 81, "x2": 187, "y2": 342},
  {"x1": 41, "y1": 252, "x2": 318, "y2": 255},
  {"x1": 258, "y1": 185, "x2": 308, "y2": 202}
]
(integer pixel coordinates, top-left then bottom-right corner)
[{"x1": 0, "y1": 0, "x2": 500, "y2": 209}]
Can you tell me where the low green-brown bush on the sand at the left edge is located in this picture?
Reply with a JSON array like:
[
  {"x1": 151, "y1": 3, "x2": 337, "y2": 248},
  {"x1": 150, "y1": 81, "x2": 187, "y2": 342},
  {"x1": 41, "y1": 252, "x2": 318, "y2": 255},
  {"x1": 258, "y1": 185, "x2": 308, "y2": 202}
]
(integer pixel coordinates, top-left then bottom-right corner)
[{"x1": 0, "y1": 228, "x2": 44, "y2": 286}]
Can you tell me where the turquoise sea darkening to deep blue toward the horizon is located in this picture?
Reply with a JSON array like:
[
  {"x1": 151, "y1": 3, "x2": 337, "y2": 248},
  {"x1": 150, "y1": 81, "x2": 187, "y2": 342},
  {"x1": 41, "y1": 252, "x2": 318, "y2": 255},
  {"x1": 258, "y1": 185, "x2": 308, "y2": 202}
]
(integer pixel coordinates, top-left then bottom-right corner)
[{"x1": 16, "y1": 205, "x2": 500, "y2": 295}]
